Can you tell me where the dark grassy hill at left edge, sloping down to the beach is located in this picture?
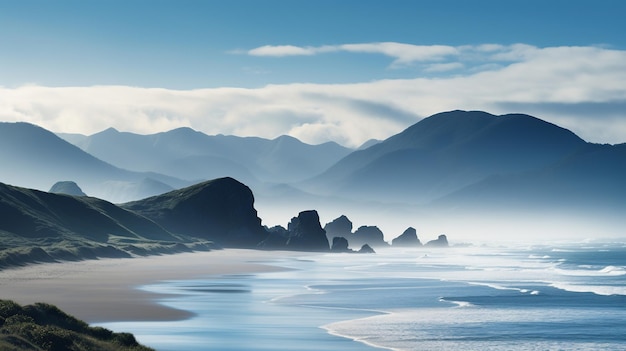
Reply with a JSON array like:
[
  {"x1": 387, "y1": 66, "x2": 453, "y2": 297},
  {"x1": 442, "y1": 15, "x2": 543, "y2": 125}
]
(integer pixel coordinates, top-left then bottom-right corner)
[{"x1": 0, "y1": 183, "x2": 207, "y2": 267}]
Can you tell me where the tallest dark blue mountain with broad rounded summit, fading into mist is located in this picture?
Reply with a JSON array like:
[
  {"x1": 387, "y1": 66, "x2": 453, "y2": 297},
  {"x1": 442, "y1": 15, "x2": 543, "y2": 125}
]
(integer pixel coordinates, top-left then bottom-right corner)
[{"x1": 302, "y1": 111, "x2": 588, "y2": 204}]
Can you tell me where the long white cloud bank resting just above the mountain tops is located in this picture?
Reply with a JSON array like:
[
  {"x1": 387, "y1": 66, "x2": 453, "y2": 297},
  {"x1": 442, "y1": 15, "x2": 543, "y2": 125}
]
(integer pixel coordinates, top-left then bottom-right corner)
[{"x1": 0, "y1": 44, "x2": 626, "y2": 147}]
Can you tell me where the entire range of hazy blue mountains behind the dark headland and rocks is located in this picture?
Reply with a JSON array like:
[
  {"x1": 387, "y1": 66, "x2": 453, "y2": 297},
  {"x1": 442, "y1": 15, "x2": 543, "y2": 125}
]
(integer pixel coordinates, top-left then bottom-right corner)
[{"x1": 0, "y1": 110, "x2": 626, "y2": 242}]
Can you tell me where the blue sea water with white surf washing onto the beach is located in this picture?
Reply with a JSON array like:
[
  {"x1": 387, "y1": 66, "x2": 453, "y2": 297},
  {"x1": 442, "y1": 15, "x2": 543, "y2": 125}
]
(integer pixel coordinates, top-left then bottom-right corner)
[{"x1": 102, "y1": 243, "x2": 626, "y2": 351}]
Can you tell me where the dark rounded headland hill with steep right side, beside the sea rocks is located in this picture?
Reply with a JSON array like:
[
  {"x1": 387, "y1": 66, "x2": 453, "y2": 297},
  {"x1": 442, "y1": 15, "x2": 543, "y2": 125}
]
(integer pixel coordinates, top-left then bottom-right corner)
[{"x1": 122, "y1": 177, "x2": 267, "y2": 248}]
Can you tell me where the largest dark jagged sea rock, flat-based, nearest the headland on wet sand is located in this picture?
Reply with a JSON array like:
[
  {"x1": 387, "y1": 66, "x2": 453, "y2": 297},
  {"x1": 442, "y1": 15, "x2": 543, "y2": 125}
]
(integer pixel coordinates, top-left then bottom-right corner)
[{"x1": 286, "y1": 210, "x2": 330, "y2": 251}]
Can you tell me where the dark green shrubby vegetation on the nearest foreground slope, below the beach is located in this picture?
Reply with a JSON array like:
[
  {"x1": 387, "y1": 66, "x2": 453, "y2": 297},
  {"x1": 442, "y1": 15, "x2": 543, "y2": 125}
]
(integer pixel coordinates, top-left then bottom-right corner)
[{"x1": 0, "y1": 300, "x2": 152, "y2": 351}]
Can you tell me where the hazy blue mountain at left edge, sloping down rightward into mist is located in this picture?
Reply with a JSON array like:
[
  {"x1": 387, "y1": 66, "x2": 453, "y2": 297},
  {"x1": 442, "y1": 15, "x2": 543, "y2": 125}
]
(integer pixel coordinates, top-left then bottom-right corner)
[{"x1": 0, "y1": 123, "x2": 188, "y2": 202}]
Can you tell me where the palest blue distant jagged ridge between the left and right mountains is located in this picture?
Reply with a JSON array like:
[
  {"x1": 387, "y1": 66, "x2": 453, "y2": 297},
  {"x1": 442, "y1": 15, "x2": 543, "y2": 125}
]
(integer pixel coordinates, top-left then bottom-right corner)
[{"x1": 60, "y1": 128, "x2": 352, "y2": 183}]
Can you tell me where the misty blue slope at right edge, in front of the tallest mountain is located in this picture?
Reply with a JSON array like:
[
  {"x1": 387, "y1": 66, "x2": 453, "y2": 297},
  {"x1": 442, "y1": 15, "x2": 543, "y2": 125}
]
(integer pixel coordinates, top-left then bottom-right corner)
[{"x1": 435, "y1": 144, "x2": 626, "y2": 213}]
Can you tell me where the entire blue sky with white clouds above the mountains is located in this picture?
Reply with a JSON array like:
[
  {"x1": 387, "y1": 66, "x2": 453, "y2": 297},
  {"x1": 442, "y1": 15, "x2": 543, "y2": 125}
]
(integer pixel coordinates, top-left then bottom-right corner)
[{"x1": 0, "y1": 0, "x2": 626, "y2": 147}]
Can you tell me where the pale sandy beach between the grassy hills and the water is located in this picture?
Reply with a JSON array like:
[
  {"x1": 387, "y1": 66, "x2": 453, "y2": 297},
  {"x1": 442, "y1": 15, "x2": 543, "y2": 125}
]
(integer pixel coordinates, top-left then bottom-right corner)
[{"x1": 0, "y1": 249, "x2": 292, "y2": 323}]
